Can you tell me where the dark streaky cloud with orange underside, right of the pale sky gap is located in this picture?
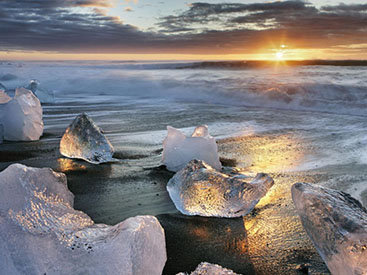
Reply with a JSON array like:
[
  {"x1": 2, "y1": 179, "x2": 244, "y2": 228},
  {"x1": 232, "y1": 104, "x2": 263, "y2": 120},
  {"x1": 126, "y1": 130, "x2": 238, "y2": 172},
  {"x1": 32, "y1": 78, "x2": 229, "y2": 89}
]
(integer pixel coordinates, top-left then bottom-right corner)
[{"x1": 159, "y1": 1, "x2": 367, "y2": 49}]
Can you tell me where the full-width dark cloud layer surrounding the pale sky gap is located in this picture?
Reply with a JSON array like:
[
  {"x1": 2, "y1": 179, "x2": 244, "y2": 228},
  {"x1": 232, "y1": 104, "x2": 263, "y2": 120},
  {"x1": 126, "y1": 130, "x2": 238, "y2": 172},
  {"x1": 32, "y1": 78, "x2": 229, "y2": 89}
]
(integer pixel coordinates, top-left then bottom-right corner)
[{"x1": 0, "y1": 0, "x2": 367, "y2": 54}]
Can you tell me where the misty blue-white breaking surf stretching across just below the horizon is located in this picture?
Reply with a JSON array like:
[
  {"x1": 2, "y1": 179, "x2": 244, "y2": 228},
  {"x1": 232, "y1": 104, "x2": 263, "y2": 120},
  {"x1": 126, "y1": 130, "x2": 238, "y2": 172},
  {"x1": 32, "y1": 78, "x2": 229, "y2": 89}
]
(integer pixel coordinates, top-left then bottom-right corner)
[{"x1": 0, "y1": 62, "x2": 367, "y2": 116}]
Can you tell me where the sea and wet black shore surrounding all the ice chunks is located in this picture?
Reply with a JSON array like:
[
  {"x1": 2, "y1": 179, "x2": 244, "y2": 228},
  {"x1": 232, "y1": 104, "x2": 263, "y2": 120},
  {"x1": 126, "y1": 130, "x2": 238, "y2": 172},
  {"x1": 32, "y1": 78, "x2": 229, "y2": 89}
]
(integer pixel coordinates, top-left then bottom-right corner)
[{"x1": 0, "y1": 61, "x2": 367, "y2": 274}]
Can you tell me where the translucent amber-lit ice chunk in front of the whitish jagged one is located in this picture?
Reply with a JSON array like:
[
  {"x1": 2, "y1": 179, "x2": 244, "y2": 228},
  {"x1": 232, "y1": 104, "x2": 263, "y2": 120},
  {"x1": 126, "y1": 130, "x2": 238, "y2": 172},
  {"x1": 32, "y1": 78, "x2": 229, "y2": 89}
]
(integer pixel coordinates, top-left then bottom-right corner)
[{"x1": 167, "y1": 160, "x2": 274, "y2": 218}]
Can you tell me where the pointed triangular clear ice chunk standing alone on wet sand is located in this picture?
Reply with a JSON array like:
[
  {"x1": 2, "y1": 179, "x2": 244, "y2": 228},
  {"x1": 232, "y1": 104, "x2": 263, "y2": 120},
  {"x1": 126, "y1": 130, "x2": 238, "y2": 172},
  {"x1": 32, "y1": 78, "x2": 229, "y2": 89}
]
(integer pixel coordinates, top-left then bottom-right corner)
[{"x1": 60, "y1": 113, "x2": 114, "y2": 164}]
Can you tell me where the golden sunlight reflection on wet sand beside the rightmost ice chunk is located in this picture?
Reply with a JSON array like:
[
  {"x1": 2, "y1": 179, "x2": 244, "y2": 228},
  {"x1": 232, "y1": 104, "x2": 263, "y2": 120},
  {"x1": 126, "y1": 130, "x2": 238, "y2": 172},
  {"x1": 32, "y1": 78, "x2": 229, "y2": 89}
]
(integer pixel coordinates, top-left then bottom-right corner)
[{"x1": 219, "y1": 133, "x2": 326, "y2": 274}]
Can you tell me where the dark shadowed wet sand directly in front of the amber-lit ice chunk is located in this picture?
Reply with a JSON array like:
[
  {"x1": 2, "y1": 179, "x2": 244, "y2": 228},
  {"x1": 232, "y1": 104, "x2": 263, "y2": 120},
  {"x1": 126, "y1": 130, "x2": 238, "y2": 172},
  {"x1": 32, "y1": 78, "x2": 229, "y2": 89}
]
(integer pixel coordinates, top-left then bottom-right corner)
[{"x1": 158, "y1": 214, "x2": 254, "y2": 274}]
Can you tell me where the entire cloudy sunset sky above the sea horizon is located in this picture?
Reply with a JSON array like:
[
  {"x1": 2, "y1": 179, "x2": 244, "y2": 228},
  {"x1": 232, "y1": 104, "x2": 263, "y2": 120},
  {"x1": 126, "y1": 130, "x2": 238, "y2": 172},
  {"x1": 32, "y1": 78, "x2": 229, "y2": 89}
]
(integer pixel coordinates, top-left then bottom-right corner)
[{"x1": 0, "y1": 0, "x2": 367, "y2": 60}]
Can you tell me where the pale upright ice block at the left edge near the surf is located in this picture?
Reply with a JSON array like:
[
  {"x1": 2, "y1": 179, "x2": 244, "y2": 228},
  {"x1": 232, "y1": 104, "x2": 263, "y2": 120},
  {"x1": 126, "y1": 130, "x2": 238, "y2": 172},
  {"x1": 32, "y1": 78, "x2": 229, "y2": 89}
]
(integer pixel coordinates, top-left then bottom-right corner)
[{"x1": 0, "y1": 88, "x2": 43, "y2": 141}]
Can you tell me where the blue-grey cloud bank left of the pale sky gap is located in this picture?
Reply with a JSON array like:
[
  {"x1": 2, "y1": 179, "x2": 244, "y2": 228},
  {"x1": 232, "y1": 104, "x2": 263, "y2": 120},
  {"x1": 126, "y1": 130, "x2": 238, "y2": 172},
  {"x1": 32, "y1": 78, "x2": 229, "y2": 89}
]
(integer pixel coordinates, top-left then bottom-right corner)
[{"x1": 0, "y1": 0, "x2": 166, "y2": 52}]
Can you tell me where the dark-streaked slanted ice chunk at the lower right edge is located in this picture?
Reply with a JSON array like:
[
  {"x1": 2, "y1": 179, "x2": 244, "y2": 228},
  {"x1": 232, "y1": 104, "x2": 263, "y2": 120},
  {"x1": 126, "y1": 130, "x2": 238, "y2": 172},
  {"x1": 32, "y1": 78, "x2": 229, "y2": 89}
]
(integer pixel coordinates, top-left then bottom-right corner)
[{"x1": 292, "y1": 183, "x2": 367, "y2": 275}]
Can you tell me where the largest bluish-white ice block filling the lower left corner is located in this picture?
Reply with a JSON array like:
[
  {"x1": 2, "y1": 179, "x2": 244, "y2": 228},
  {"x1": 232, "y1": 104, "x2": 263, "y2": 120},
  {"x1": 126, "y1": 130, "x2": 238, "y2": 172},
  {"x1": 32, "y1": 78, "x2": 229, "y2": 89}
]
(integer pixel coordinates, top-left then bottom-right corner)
[{"x1": 0, "y1": 164, "x2": 166, "y2": 275}]
